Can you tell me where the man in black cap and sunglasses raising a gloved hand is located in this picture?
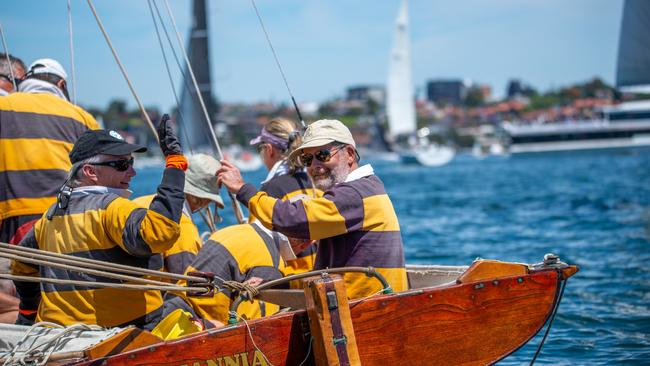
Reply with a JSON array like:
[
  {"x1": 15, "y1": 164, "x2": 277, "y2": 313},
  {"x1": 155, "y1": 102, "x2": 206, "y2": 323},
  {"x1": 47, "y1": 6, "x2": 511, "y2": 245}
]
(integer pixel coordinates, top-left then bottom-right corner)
[{"x1": 12, "y1": 115, "x2": 187, "y2": 329}]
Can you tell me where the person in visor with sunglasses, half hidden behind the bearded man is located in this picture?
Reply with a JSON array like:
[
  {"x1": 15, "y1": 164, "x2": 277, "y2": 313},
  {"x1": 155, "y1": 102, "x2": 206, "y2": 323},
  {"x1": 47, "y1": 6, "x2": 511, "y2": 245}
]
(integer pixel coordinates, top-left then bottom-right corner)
[{"x1": 250, "y1": 118, "x2": 322, "y2": 280}]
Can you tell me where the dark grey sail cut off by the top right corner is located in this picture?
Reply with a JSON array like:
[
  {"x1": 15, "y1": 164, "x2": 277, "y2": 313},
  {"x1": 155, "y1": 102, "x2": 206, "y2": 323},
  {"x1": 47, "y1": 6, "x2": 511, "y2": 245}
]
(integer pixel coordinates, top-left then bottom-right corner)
[{"x1": 616, "y1": 0, "x2": 650, "y2": 92}]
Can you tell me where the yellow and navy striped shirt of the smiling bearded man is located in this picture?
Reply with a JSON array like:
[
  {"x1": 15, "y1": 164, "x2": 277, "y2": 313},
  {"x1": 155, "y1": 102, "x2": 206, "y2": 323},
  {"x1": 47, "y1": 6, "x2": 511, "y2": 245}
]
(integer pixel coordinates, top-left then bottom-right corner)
[{"x1": 237, "y1": 165, "x2": 408, "y2": 298}]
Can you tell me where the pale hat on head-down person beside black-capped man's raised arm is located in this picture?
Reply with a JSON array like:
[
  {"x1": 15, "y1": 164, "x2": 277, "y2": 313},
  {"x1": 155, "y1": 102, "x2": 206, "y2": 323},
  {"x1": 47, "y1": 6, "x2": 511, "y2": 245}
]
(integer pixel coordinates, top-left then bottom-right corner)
[{"x1": 184, "y1": 154, "x2": 224, "y2": 208}]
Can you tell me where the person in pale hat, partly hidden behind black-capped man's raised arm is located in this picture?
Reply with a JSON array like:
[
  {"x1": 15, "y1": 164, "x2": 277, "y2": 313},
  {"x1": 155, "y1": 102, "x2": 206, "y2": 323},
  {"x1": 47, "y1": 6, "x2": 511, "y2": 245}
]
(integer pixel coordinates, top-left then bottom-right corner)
[{"x1": 133, "y1": 154, "x2": 224, "y2": 274}]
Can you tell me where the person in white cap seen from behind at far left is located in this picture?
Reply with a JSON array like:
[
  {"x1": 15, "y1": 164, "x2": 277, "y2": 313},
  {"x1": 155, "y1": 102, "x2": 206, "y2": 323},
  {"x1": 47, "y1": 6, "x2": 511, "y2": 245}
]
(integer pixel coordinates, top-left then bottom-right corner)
[{"x1": 0, "y1": 57, "x2": 99, "y2": 243}]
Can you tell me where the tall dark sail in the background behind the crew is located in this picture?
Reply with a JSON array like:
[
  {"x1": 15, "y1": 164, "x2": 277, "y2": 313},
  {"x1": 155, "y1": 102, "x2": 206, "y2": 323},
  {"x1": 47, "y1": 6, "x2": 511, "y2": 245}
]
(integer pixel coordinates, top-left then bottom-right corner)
[{"x1": 179, "y1": 0, "x2": 217, "y2": 149}]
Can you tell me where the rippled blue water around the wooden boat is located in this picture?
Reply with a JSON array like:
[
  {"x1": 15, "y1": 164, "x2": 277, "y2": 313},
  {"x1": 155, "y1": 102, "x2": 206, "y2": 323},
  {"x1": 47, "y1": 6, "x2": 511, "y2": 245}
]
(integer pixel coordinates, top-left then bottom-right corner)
[{"x1": 133, "y1": 150, "x2": 650, "y2": 365}]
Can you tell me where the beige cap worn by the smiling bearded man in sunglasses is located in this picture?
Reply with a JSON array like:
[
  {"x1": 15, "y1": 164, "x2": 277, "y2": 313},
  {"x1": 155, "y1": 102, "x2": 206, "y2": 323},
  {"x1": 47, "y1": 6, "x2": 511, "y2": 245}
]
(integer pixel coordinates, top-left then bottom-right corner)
[{"x1": 289, "y1": 119, "x2": 357, "y2": 159}]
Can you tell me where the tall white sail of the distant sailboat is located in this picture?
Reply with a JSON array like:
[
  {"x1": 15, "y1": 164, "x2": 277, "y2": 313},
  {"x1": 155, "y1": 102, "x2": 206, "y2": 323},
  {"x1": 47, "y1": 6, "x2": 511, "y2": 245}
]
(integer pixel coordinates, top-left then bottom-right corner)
[{"x1": 387, "y1": 0, "x2": 416, "y2": 136}]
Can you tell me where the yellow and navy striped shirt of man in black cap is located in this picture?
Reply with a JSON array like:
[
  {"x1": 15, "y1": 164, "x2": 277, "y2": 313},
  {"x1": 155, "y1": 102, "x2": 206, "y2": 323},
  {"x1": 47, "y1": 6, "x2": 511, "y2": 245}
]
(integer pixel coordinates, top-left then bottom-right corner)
[{"x1": 12, "y1": 168, "x2": 185, "y2": 329}]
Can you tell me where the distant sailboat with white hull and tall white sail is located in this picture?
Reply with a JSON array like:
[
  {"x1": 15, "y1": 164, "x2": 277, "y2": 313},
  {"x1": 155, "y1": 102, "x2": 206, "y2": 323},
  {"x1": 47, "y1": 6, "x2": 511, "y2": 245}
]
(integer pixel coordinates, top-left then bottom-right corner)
[{"x1": 386, "y1": 0, "x2": 455, "y2": 166}]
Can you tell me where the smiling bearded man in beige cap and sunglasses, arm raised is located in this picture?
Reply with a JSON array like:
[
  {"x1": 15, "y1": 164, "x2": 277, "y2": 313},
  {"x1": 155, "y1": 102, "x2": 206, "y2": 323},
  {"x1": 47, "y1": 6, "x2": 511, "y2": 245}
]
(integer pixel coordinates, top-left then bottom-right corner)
[{"x1": 218, "y1": 120, "x2": 407, "y2": 298}]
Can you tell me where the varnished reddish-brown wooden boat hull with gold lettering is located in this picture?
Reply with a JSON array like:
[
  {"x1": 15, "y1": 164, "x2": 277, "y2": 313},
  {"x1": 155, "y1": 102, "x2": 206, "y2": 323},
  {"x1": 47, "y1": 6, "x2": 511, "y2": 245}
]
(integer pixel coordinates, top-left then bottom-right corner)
[{"x1": 77, "y1": 267, "x2": 577, "y2": 366}]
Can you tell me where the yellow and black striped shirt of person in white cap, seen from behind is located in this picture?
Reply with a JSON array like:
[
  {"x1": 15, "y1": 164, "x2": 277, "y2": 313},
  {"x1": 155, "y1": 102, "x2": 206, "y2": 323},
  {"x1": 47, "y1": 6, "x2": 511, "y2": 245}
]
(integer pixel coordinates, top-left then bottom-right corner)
[{"x1": 0, "y1": 93, "x2": 99, "y2": 220}]
